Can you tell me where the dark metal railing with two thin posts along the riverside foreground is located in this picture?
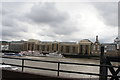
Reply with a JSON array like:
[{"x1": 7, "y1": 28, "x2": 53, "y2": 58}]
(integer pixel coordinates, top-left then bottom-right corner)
[{"x1": 1, "y1": 56, "x2": 120, "y2": 78}]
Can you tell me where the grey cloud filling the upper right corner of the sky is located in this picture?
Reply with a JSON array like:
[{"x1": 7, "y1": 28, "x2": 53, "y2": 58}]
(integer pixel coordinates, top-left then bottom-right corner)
[{"x1": 93, "y1": 2, "x2": 118, "y2": 27}]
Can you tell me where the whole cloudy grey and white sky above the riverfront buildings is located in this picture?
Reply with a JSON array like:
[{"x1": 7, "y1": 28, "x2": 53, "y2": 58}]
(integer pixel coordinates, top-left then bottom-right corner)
[{"x1": 0, "y1": 1, "x2": 118, "y2": 42}]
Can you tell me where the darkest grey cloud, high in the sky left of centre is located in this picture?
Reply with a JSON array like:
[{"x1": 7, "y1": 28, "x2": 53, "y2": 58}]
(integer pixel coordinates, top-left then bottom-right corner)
[{"x1": 27, "y1": 2, "x2": 68, "y2": 24}]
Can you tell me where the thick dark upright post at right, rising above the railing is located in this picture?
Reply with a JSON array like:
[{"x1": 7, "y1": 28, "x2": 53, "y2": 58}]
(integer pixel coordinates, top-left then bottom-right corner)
[{"x1": 99, "y1": 46, "x2": 107, "y2": 80}]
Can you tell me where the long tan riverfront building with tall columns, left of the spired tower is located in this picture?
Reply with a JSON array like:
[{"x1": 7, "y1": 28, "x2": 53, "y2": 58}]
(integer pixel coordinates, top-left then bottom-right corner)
[{"x1": 17, "y1": 39, "x2": 92, "y2": 55}]
